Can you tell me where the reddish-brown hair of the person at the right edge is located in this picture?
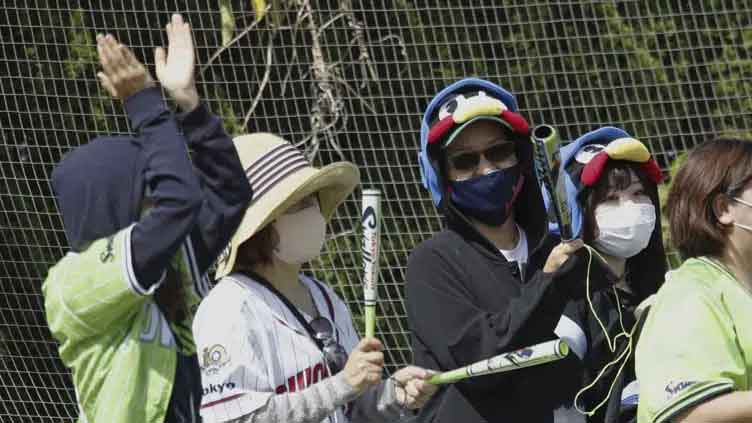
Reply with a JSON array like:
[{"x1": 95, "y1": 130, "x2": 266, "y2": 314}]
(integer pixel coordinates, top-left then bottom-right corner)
[{"x1": 666, "y1": 138, "x2": 752, "y2": 258}]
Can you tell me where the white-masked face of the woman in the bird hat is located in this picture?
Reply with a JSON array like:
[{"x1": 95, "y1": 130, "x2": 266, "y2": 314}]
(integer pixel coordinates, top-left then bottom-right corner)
[{"x1": 595, "y1": 174, "x2": 656, "y2": 259}]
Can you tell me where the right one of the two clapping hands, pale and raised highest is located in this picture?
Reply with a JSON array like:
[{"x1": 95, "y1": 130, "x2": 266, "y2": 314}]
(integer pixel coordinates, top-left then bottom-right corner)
[{"x1": 154, "y1": 13, "x2": 199, "y2": 112}]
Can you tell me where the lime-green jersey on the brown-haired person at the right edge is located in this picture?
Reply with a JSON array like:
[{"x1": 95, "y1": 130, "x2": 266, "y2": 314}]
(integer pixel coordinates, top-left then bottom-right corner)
[{"x1": 636, "y1": 257, "x2": 752, "y2": 423}]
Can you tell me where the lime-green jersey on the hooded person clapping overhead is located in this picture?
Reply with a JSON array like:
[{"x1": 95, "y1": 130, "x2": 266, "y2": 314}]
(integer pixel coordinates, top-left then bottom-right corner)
[{"x1": 42, "y1": 226, "x2": 200, "y2": 423}]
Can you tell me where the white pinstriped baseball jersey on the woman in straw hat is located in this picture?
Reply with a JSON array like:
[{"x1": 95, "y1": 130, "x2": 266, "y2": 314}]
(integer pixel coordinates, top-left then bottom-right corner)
[{"x1": 193, "y1": 273, "x2": 359, "y2": 423}]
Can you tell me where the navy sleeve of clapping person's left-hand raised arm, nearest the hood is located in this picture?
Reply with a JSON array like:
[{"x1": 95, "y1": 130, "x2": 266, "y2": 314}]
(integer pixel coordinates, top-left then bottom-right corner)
[{"x1": 125, "y1": 87, "x2": 201, "y2": 290}]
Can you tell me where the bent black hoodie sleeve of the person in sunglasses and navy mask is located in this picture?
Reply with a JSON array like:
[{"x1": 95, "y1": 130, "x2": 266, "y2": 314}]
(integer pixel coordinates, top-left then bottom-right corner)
[{"x1": 407, "y1": 245, "x2": 566, "y2": 392}]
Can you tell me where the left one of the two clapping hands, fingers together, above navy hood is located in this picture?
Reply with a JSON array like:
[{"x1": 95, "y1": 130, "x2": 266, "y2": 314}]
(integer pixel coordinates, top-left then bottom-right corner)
[{"x1": 97, "y1": 34, "x2": 154, "y2": 100}]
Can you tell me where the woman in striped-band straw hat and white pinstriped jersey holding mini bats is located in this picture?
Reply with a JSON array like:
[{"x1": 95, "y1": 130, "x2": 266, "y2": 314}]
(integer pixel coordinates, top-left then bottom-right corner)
[{"x1": 193, "y1": 134, "x2": 436, "y2": 423}]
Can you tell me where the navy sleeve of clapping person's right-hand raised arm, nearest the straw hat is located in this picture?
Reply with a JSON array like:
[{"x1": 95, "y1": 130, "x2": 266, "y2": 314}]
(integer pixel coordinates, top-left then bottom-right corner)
[{"x1": 178, "y1": 103, "x2": 252, "y2": 274}]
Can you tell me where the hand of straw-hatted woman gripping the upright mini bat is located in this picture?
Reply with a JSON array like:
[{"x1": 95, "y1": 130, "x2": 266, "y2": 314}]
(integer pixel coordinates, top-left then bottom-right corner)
[{"x1": 342, "y1": 338, "x2": 384, "y2": 393}]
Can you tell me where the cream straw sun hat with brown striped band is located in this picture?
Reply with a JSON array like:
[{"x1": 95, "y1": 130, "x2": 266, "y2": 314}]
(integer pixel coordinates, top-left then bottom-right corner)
[{"x1": 216, "y1": 133, "x2": 360, "y2": 278}]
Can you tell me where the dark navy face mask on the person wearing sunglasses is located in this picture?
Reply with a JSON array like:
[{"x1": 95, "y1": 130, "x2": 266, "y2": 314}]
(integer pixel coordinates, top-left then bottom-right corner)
[{"x1": 449, "y1": 165, "x2": 525, "y2": 226}]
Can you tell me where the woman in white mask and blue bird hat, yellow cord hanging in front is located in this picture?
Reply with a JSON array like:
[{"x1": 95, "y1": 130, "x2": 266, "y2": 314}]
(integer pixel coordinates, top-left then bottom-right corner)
[{"x1": 544, "y1": 127, "x2": 666, "y2": 423}]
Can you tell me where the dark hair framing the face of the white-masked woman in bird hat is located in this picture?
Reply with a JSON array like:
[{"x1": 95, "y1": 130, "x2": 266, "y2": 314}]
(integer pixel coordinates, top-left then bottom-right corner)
[{"x1": 580, "y1": 160, "x2": 660, "y2": 244}]
